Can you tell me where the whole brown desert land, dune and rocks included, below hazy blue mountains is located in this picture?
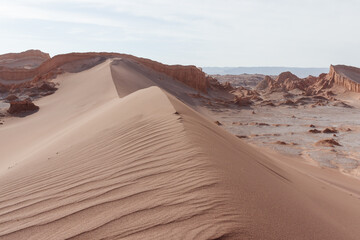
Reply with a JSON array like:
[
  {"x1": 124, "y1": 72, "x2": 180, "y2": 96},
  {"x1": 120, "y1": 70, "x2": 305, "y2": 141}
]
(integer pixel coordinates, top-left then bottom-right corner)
[{"x1": 0, "y1": 50, "x2": 360, "y2": 240}]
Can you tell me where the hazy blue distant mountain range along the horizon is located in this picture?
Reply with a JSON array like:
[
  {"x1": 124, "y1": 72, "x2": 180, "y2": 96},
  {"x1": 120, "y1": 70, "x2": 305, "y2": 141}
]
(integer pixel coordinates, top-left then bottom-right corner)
[{"x1": 202, "y1": 67, "x2": 329, "y2": 78}]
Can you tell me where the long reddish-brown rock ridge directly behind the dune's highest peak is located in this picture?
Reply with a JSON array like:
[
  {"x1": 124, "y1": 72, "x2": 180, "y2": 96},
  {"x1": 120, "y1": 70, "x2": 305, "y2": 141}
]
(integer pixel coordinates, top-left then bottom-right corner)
[{"x1": 0, "y1": 53, "x2": 209, "y2": 93}]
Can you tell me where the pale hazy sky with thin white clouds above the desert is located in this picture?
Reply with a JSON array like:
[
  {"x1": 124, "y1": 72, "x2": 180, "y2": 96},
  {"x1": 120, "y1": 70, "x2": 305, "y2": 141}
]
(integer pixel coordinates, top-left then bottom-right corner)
[{"x1": 0, "y1": 0, "x2": 360, "y2": 67}]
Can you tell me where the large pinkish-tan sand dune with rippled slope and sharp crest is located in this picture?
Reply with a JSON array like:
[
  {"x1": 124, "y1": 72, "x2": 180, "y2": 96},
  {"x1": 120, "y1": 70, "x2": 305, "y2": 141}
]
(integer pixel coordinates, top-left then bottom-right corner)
[{"x1": 0, "y1": 57, "x2": 360, "y2": 239}]
